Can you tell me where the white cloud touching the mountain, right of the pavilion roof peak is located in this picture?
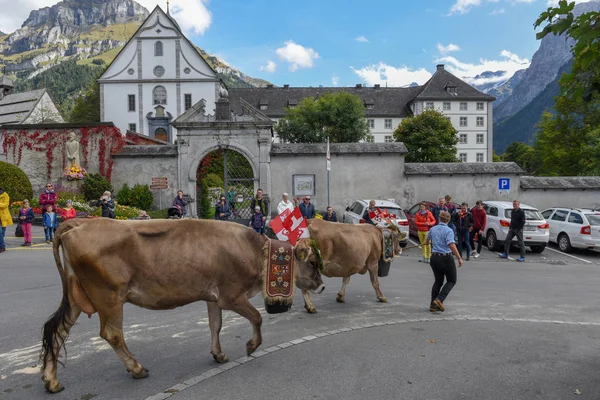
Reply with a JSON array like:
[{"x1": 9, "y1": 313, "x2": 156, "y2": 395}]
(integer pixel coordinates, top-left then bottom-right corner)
[{"x1": 436, "y1": 50, "x2": 531, "y2": 85}]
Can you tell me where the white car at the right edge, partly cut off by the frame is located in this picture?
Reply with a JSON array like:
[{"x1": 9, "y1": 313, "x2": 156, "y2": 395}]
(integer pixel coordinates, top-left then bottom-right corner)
[{"x1": 542, "y1": 207, "x2": 600, "y2": 253}]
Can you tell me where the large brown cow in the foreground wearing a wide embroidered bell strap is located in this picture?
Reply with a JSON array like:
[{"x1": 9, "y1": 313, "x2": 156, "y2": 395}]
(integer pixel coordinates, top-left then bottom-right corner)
[{"x1": 42, "y1": 218, "x2": 323, "y2": 393}]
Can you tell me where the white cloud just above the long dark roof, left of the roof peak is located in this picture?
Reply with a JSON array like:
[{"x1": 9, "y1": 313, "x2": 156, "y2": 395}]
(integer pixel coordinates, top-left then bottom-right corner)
[{"x1": 350, "y1": 62, "x2": 431, "y2": 86}]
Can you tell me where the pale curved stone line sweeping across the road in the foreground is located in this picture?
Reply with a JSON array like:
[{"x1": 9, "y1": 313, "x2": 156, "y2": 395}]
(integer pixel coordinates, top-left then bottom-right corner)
[{"x1": 145, "y1": 315, "x2": 600, "y2": 400}]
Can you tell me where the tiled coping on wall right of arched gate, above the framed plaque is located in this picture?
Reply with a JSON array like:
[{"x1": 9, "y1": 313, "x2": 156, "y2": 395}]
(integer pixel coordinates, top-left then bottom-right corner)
[{"x1": 271, "y1": 143, "x2": 408, "y2": 155}]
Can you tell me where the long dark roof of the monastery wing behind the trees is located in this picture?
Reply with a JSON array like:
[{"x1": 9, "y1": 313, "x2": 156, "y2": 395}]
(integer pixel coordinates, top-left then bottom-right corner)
[{"x1": 229, "y1": 87, "x2": 420, "y2": 118}]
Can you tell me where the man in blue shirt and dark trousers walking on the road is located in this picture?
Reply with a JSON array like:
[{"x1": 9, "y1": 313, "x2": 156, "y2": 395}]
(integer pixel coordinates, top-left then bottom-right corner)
[{"x1": 427, "y1": 211, "x2": 463, "y2": 312}]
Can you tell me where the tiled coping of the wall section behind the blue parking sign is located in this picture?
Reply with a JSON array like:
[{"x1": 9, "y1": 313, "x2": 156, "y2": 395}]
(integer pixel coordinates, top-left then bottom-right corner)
[{"x1": 404, "y1": 162, "x2": 525, "y2": 175}]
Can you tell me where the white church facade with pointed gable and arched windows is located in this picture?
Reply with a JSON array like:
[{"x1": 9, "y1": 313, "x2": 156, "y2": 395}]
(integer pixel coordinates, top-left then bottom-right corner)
[{"x1": 98, "y1": 3, "x2": 220, "y2": 143}]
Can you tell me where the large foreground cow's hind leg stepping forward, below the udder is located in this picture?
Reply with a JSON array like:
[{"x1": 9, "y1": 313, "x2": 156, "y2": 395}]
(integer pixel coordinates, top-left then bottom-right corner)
[{"x1": 98, "y1": 304, "x2": 150, "y2": 379}]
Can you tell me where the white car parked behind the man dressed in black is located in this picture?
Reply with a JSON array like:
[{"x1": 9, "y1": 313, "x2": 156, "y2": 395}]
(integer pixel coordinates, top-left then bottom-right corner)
[{"x1": 483, "y1": 201, "x2": 550, "y2": 253}]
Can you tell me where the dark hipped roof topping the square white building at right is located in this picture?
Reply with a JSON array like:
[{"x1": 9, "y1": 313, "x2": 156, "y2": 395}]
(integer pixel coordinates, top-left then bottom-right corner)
[{"x1": 414, "y1": 64, "x2": 496, "y2": 101}]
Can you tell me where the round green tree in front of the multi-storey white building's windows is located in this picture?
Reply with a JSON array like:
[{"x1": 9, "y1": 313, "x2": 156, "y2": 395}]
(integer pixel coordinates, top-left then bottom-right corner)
[{"x1": 394, "y1": 110, "x2": 458, "y2": 162}]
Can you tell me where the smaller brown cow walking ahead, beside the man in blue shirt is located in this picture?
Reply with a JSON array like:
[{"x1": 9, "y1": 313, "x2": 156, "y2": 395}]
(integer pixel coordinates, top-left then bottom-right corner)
[{"x1": 296, "y1": 219, "x2": 402, "y2": 313}]
